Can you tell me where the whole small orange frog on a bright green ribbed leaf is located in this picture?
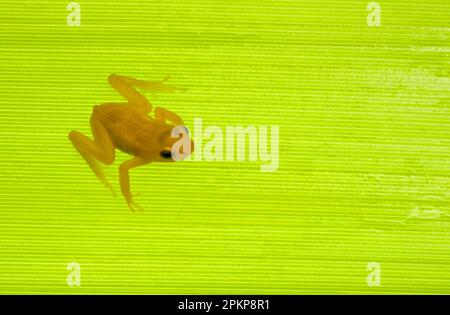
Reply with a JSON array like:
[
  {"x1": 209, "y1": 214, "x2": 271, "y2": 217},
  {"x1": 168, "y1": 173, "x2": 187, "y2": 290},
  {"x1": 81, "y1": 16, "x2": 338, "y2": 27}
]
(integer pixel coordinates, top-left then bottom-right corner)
[{"x1": 69, "y1": 74, "x2": 194, "y2": 211}]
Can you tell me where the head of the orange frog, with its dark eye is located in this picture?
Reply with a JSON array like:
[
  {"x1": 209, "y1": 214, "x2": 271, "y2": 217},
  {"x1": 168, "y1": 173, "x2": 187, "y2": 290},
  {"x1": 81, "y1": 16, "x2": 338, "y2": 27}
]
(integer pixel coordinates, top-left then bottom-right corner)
[{"x1": 158, "y1": 126, "x2": 194, "y2": 162}]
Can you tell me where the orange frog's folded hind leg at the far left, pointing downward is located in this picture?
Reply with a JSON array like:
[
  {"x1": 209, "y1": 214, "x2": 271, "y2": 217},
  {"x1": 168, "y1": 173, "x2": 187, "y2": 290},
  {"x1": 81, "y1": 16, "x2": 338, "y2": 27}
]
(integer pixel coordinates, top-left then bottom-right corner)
[{"x1": 69, "y1": 106, "x2": 116, "y2": 196}]
